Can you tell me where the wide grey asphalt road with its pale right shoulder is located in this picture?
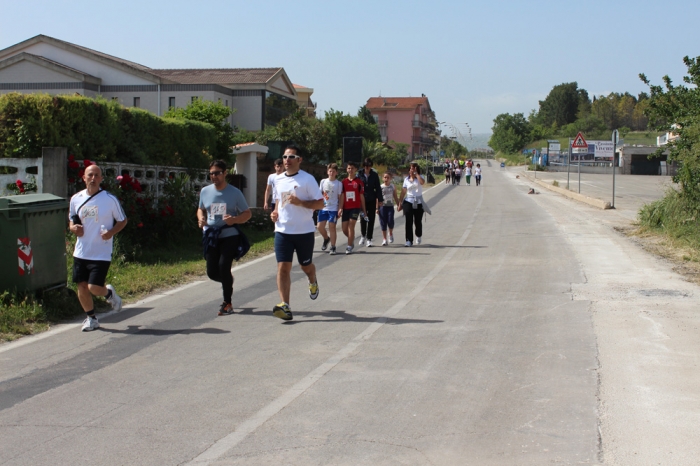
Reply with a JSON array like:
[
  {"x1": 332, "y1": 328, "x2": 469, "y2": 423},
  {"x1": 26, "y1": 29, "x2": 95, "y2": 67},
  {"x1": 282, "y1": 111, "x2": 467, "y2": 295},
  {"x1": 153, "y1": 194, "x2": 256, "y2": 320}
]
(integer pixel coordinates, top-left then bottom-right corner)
[{"x1": 0, "y1": 161, "x2": 700, "y2": 465}]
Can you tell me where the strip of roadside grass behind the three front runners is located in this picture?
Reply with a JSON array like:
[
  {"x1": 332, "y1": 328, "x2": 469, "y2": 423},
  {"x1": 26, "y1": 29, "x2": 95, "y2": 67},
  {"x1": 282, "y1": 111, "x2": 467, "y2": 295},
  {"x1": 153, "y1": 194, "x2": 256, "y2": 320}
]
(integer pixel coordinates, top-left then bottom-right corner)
[{"x1": 0, "y1": 229, "x2": 274, "y2": 341}]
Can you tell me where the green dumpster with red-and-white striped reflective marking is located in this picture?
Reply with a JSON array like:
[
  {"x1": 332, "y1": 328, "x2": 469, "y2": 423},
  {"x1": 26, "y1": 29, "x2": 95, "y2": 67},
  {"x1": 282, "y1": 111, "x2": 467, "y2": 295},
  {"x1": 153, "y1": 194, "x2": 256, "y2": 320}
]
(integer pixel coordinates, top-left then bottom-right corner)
[{"x1": 0, "y1": 194, "x2": 68, "y2": 291}]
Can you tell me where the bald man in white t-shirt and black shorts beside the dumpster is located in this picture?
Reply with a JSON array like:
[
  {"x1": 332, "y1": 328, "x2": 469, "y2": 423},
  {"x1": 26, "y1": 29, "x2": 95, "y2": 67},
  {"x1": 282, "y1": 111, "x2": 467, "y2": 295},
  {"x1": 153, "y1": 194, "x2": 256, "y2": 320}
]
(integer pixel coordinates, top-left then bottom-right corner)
[{"x1": 68, "y1": 165, "x2": 127, "y2": 332}]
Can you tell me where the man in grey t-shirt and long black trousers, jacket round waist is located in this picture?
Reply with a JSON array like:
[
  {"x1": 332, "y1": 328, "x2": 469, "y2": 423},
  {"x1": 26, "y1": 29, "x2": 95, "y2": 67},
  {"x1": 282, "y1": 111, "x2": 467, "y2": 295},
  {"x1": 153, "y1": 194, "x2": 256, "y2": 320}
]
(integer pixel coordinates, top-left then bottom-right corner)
[{"x1": 197, "y1": 160, "x2": 252, "y2": 316}]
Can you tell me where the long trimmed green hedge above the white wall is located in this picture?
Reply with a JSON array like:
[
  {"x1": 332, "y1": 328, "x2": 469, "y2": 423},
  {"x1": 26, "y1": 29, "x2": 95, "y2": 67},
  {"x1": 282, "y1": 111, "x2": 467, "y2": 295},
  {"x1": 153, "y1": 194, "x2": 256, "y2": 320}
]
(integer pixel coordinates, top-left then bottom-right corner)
[{"x1": 0, "y1": 93, "x2": 217, "y2": 168}]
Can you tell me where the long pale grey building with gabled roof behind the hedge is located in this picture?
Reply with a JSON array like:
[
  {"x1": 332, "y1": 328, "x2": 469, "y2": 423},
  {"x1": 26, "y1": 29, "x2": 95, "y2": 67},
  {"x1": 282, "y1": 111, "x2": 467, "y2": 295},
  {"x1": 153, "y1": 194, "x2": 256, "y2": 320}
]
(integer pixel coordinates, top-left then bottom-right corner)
[{"x1": 0, "y1": 35, "x2": 313, "y2": 131}]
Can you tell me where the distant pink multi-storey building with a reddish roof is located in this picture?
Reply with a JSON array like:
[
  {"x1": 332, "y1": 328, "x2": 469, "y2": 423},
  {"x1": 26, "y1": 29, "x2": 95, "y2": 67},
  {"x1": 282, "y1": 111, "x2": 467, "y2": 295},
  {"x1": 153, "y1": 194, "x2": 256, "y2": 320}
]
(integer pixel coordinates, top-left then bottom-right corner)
[{"x1": 366, "y1": 95, "x2": 437, "y2": 156}]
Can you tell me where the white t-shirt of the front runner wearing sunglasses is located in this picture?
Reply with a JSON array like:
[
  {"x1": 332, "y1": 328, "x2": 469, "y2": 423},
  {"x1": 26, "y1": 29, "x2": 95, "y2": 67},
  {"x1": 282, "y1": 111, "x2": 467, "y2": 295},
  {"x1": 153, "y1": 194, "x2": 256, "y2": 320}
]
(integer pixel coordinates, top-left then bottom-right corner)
[{"x1": 274, "y1": 170, "x2": 323, "y2": 235}]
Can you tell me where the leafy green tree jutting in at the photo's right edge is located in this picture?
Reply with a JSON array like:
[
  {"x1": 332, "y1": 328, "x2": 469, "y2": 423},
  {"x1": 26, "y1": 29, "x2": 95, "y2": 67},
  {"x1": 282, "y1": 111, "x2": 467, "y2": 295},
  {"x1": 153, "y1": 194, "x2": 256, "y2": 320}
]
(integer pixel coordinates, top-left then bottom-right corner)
[{"x1": 639, "y1": 56, "x2": 700, "y2": 205}]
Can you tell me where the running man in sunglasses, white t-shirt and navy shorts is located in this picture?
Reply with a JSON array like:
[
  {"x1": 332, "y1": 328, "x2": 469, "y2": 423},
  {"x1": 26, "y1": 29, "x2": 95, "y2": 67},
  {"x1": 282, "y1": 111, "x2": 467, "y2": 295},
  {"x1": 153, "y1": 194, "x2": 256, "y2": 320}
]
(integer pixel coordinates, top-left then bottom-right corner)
[{"x1": 270, "y1": 144, "x2": 323, "y2": 320}]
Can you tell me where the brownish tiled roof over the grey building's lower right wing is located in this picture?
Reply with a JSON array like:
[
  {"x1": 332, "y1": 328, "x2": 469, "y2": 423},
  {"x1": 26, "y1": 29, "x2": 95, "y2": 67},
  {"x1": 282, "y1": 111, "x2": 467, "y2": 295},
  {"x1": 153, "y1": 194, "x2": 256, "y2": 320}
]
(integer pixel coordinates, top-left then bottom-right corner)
[{"x1": 150, "y1": 68, "x2": 282, "y2": 84}]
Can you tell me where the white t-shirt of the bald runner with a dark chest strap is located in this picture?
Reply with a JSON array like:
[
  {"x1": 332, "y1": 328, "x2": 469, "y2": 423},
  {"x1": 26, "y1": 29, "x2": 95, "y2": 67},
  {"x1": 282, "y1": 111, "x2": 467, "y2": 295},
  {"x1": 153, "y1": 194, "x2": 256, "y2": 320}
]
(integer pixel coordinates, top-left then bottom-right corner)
[{"x1": 68, "y1": 189, "x2": 126, "y2": 261}]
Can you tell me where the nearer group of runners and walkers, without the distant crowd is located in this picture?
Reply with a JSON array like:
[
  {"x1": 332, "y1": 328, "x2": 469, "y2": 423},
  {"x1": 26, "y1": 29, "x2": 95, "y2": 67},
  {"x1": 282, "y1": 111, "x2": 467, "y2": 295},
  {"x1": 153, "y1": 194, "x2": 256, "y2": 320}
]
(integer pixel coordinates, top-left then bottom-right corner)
[{"x1": 69, "y1": 144, "x2": 430, "y2": 331}]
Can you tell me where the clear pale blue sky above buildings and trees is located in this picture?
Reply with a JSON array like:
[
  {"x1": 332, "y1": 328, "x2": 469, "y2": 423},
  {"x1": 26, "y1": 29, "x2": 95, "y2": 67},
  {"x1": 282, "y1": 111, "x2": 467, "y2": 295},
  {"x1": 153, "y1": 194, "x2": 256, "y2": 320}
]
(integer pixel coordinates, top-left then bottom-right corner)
[{"x1": 0, "y1": 0, "x2": 700, "y2": 147}]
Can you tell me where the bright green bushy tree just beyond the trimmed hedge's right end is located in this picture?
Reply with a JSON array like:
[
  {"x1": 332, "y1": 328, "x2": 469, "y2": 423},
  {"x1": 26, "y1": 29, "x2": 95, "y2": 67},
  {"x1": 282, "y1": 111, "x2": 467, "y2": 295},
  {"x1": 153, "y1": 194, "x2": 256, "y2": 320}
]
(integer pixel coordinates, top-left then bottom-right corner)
[{"x1": 163, "y1": 98, "x2": 235, "y2": 159}]
